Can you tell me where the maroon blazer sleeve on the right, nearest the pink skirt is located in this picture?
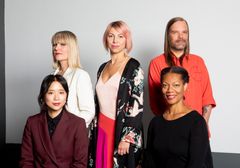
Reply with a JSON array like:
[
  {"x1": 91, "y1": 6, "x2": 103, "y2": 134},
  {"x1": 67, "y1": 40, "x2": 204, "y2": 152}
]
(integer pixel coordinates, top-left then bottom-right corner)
[{"x1": 71, "y1": 120, "x2": 88, "y2": 168}]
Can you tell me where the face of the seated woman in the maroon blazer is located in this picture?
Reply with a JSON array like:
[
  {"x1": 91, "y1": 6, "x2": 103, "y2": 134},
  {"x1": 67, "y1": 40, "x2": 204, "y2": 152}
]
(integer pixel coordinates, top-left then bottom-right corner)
[{"x1": 44, "y1": 81, "x2": 67, "y2": 114}]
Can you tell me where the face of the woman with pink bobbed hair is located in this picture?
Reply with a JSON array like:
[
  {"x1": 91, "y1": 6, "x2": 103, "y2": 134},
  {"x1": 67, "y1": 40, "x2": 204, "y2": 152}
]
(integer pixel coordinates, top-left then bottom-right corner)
[{"x1": 107, "y1": 28, "x2": 126, "y2": 54}]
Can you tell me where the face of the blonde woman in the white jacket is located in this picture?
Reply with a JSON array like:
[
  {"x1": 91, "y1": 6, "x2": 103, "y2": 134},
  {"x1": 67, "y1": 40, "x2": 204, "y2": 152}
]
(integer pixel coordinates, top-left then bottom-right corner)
[{"x1": 52, "y1": 41, "x2": 69, "y2": 62}]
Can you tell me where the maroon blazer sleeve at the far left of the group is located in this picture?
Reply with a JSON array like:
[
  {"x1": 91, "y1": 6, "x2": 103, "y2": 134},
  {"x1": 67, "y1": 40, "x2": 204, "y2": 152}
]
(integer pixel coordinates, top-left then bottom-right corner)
[{"x1": 20, "y1": 119, "x2": 34, "y2": 168}]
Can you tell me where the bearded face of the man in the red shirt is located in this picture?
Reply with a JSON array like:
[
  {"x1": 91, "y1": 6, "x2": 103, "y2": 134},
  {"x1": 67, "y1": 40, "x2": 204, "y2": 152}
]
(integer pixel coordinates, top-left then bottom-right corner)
[{"x1": 168, "y1": 21, "x2": 189, "y2": 52}]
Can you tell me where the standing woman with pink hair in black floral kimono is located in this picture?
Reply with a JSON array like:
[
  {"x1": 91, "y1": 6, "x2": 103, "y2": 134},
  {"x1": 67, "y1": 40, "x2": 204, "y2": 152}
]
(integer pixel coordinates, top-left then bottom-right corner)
[{"x1": 88, "y1": 21, "x2": 144, "y2": 168}]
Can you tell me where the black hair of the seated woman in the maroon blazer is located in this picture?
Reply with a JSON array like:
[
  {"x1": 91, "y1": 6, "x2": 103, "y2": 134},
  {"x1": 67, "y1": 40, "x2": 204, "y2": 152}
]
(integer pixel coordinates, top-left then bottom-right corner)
[{"x1": 38, "y1": 75, "x2": 69, "y2": 108}]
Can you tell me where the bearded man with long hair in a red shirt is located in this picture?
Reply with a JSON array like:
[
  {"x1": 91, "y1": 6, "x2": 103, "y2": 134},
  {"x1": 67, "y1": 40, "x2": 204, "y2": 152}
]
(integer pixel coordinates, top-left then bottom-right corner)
[{"x1": 148, "y1": 17, "x2": 216, "y2": 123}]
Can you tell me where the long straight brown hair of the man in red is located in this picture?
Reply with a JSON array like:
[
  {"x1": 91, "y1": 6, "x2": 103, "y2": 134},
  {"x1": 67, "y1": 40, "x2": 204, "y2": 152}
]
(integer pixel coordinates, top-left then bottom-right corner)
[{"x1": 164, "y1": 17, "x2": 190, "y2": 66}]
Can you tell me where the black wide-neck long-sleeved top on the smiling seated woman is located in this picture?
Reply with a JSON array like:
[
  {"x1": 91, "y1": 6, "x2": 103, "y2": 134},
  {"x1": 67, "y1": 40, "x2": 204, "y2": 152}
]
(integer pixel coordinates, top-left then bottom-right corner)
[{"x1": 144, "y1": 111, "x2": 213, "y2": 168}]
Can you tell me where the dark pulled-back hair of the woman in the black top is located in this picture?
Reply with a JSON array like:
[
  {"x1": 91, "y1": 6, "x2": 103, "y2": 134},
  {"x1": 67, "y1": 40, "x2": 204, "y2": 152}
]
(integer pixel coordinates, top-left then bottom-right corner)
[{"x1": 160, "y1": 66, "x2": 189, "y2": 84}]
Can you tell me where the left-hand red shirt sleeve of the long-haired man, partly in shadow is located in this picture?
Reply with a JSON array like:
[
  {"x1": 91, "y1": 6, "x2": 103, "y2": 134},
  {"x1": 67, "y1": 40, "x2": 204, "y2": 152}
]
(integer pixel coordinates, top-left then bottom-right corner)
[{"x1": 148, "y1": 60, "x2": 165, "y2": 115}]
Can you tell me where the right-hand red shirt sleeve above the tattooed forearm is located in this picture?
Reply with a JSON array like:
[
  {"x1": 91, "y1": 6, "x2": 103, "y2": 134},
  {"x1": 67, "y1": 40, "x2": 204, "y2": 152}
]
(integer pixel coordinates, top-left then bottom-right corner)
[{"x1": 199, "y1": 60, "x2": 216, "y2": 107}]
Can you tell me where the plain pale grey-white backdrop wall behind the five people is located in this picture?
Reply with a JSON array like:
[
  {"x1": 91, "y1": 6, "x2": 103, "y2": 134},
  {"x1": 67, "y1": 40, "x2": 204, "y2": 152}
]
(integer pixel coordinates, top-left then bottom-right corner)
[{"x1": 5, "y1": 0, "x2": 240, "y2": 153}]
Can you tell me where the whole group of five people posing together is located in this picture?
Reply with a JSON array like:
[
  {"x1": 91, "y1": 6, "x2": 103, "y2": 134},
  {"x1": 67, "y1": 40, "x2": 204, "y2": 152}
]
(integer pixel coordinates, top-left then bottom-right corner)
[{"x1": 20, "y1": 17, "x2": 216, "y2": 168}]
